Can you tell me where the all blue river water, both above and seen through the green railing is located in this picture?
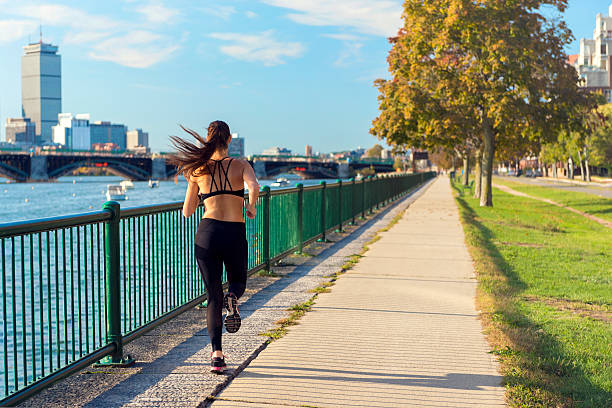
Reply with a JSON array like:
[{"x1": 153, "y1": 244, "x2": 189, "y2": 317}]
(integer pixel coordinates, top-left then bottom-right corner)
[{"x1": 0, "y1": 175, "x2": 340, "y2": 399}]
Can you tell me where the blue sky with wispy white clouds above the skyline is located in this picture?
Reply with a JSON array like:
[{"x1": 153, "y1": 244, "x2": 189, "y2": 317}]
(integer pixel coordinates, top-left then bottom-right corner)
[{"x1": 0, "y1": 0, "x2": 610, "y2": 154}]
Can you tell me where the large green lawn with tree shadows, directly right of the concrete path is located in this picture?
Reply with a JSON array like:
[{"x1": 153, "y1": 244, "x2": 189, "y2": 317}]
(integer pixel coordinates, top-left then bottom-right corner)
[{"x1": 453, "y1": 184, "x2": 612, "y2": 408}]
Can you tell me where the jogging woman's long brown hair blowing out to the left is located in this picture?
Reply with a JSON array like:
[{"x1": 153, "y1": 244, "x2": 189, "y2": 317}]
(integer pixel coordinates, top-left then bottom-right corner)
[{"x1": 168, "y1": 120, "x2": 231, "y2": 177}]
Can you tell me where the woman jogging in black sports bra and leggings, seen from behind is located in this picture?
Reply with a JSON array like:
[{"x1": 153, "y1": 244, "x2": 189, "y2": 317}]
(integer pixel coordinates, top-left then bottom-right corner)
[{"x1": 171, "y1": 120, "x2": 259, "y2": 373}]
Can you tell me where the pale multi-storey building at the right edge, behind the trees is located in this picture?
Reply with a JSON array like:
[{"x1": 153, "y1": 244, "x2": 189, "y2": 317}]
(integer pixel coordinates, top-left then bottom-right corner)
[{"x1": 570, "y1": 5, "x2": 612, "y2": 100}]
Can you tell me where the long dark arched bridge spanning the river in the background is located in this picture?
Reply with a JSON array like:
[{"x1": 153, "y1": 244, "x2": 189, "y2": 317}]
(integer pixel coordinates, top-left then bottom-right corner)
[{"x1": 0, "y1": 152, "x2": 393, "y2": 182}]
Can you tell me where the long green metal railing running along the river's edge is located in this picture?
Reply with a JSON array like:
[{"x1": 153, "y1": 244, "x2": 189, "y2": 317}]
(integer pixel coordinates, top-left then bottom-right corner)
[{"x1": 0, "y1": 173, "x2": 434, "y2": 405}]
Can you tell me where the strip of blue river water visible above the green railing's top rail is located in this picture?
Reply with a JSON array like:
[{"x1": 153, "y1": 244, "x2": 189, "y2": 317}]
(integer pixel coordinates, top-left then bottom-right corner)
[{"x1": 0, "y1": 175, "x2": 330, "y2": 224}]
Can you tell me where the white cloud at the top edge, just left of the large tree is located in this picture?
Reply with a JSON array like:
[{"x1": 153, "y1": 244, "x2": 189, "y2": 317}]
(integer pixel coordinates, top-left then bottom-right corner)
[{"x1": 261, "y1": 0, "x2": 402, "y2": 37}]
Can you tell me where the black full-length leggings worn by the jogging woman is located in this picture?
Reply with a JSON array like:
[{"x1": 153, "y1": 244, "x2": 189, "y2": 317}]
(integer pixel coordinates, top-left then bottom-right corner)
[{"x1": 195, "y1": 218, "x2": 248, "y2": 351}]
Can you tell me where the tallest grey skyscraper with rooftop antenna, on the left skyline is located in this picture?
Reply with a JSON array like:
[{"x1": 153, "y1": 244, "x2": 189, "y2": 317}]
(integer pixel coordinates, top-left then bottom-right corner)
[{"x1": 21, "y1": 40, "x2": 62, "y2": 144}]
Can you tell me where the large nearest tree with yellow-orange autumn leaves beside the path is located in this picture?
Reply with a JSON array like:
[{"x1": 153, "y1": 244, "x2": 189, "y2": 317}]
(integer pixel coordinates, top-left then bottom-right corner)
[{"x1": 371, "y1": 0, "x2": 588, "y2": 206}]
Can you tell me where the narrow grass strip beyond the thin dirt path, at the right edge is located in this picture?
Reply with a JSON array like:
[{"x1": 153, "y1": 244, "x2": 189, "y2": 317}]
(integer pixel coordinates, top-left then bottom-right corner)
[{"x1": 494, "y1": 177, "x2": 612, "y2": 221}]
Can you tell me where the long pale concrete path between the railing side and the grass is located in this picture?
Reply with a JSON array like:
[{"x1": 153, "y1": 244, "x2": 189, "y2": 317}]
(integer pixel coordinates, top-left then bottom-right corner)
[{"x1": 212, "y1": 178, "x2": 505, "y2": 408}]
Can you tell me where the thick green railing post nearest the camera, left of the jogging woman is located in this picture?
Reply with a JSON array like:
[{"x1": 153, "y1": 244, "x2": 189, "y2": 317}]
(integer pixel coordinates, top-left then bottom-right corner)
[{"x1": 97, "y1": 201, "x2": 134, "y2": 367}]
